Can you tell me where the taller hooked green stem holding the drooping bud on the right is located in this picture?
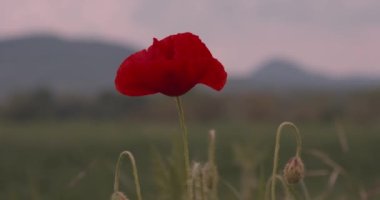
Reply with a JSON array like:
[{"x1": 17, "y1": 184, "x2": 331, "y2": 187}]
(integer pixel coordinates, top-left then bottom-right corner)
[{"x1": 271, "y1": 122, "x2": 302, "y2": 200}]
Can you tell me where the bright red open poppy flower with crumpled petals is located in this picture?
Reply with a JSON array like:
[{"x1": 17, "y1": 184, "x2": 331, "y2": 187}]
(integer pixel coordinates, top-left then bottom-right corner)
[{"x1": 115, "y1": 33, "x2": 227, "y2": 96}]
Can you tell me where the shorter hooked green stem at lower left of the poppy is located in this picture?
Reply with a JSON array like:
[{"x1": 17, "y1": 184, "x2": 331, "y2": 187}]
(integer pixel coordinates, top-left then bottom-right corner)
[{"x1": 114, "y1": 151, "x2": 142, "y2": 200}]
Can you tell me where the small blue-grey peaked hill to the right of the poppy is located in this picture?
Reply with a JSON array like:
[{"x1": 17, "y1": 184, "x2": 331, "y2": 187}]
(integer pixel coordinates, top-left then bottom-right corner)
[{"x1": 227, "y1": 58, "x2": 380, "y2": 93}]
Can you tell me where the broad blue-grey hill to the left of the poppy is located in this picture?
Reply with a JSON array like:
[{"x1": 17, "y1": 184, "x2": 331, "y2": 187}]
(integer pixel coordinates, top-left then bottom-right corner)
[{"x1": 0, "y1": 35, "x2": 134, "y2": 97}]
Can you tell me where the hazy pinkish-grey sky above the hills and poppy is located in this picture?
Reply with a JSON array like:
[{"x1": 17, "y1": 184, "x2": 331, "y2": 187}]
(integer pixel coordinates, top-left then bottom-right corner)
[{"x1": 0, "y1": 0, "x2": 380, "y2": 77}]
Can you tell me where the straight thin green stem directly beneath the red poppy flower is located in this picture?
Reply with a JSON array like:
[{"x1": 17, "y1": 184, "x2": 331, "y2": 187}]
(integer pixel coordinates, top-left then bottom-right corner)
[{"x1": 175, "y1": 96, "x2": 192, "y2": 200}]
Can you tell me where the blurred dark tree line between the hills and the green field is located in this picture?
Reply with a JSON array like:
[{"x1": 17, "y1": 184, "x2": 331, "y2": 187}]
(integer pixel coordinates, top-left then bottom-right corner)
[{"x1": 0, "y1": 88, "x2": 380, "y2": 121}]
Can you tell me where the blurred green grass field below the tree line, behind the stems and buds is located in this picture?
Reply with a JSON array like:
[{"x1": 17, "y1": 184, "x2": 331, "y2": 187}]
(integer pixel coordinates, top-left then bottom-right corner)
[{"x1": 0, "y1": 119, "x2": 380, "y2": 200}]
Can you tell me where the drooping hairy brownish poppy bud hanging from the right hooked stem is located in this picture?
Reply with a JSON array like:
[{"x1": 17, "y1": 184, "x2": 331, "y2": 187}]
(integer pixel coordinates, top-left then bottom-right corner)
[{"x1": 284, "y1": 156, "x2": 305, "y2": 184}]
